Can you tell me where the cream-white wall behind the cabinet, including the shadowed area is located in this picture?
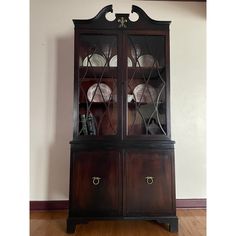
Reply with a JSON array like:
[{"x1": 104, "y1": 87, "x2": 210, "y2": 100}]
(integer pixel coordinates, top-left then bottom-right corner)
[{"x1": 30, "y1": 0, "x2": 206, "y2": 200}]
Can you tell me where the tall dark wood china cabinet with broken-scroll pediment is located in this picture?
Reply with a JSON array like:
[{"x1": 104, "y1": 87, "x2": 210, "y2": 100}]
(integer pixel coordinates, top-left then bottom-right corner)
[{"x1": 67, "y1": 5, "x2": 178, "y2": 233}]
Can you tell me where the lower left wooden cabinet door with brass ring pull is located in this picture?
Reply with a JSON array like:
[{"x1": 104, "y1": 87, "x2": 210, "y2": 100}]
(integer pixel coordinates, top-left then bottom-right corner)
[{"x1": 70, "y1": 150, "x2": 121, "y2": 217}]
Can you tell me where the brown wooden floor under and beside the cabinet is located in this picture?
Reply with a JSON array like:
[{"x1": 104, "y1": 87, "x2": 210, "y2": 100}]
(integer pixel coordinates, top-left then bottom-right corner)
[{"x1": 30, "y1": 209, "x2": 206, "y2": 236}]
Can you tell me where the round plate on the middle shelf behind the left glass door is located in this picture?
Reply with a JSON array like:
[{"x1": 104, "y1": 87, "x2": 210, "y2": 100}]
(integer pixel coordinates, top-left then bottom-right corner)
[{"x1": 87, "y1": 83, "x2": 111, "y2": 102}]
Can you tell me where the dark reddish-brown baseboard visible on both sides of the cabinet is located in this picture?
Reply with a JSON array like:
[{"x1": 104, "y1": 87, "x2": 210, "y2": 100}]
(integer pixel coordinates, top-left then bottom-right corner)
[{"x1": 30, "y1": 198, "x2": 206, "y2": 211}]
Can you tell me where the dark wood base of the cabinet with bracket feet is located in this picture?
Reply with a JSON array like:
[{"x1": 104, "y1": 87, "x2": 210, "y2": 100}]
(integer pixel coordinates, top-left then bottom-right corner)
[{"x1": 67, "y1": 216, "x2": 178, "y2": 234}]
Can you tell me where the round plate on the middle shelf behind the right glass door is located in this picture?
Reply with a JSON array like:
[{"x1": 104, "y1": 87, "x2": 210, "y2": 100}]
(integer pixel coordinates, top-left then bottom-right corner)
[{"x1": 133, "y1": 84, "x2": 157, "y2": 103}]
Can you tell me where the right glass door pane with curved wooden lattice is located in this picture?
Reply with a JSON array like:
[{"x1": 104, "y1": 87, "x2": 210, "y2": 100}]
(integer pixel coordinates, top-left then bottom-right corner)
[{"x1": 127, "y1": 36, "x2": 167, "y2": 135}]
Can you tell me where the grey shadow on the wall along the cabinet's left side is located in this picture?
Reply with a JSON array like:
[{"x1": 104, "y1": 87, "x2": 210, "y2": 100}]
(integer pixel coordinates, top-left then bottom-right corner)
[{"x1": 47, "y1": 35, "x2": 74, "y2": 200}]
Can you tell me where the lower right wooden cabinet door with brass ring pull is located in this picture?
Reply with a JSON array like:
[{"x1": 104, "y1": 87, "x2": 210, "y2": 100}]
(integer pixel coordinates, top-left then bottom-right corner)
[{"x1": 124, "y1": 150, "x2": 175, "y2": 216}]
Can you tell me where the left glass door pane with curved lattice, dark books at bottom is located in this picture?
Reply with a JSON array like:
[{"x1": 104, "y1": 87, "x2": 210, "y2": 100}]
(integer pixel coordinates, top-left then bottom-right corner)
[{"x1": 79, "y1": 35, "x2": 118, "y2": 136}]
